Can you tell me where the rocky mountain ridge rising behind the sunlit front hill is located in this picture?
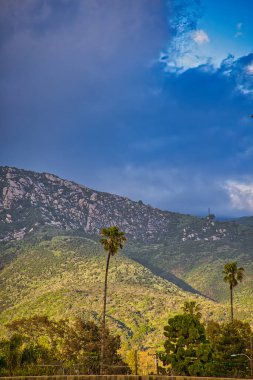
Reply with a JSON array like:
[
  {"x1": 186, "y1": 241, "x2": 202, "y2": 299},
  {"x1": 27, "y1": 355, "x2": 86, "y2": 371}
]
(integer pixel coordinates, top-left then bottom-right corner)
[{"x1": 0, "y1": 167, "x2": 253, "y2": 326}]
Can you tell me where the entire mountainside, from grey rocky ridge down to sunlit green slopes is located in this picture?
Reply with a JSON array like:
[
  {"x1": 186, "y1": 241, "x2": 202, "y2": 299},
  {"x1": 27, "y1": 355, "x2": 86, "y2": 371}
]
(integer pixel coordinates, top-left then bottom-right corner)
[{"x1": 0, "y1": 167, "x2": 253, "y2": 345}]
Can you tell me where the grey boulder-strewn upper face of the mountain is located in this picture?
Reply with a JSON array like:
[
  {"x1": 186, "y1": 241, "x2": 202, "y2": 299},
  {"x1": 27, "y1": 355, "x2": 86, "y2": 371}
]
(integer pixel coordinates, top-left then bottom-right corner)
[{"x1": 0, "y1": 167, "x2": 240, "y2": 241}]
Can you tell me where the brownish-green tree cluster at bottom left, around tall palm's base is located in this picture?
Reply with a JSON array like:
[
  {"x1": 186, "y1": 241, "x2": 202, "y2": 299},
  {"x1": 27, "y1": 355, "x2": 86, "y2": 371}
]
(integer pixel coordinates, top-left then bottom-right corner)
[{"x1": 0, "y1": 316, "x2": 129, "y2": 375}]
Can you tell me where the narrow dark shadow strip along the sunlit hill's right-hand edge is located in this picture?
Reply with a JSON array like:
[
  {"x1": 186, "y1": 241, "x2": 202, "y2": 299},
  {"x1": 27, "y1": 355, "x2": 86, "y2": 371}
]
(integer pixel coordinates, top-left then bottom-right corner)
[{"x1": 132, "y1": 258, "x2": 215, "y2": 301}]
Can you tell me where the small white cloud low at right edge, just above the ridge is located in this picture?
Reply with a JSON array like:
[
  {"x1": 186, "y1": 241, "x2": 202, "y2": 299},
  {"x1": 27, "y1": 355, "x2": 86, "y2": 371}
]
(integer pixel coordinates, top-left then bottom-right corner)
[{"x1": 224, "y1": 181, "x2": 253, "y2": 211}]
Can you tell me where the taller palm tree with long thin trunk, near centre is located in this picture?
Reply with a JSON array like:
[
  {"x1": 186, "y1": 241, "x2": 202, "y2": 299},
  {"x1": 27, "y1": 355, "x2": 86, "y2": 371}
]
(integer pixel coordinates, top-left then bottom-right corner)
[{"x1": 100, "y1": 226, "x2": 126, "y2": 375}]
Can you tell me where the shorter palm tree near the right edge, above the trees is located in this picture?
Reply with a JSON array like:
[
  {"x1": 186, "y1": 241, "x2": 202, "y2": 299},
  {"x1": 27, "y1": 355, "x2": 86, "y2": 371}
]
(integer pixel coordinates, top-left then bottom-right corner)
[{"x1": 222, "y1": 261, "x2": 244, "y2": 323}]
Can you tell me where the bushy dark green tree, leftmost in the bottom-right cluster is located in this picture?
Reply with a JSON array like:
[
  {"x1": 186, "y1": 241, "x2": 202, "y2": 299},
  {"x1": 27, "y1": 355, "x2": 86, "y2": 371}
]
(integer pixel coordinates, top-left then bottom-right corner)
[{"x1": 160, "y1": 314, "x2": 212, "y2": 376}]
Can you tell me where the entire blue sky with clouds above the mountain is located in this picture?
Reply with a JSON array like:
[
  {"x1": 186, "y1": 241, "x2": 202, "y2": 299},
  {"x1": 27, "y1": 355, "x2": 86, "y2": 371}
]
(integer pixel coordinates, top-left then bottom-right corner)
[{"x1": 0, "y1": 0, "x2": 253, "y2": 217}]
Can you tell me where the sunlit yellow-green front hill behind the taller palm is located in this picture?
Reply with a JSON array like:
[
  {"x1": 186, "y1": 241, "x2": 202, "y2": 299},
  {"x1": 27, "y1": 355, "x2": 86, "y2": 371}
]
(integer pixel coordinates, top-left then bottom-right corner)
[{"x1": 0, "y1": 237, "x2": 228, "y2": 347}]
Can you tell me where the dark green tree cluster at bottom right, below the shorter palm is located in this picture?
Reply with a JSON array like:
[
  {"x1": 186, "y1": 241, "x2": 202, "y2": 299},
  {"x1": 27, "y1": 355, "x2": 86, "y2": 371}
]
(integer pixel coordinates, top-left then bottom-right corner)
[{"x1": 160, "y1": 301, "x2": 252, "y2": 377}]
